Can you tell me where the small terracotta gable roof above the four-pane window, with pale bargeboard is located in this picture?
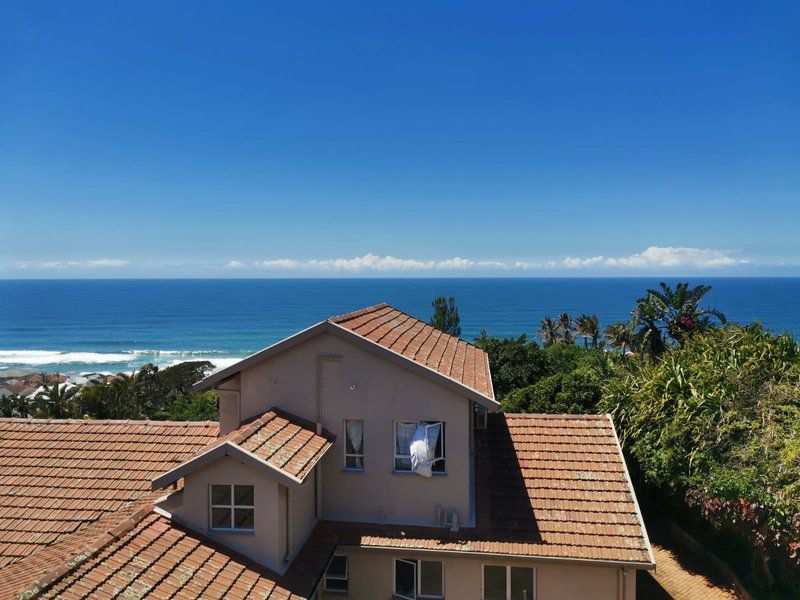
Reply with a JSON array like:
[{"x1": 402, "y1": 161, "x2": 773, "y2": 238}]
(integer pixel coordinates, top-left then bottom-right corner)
[{"x1": 153, "y1": 408, "x2": 336, "y2": 487}]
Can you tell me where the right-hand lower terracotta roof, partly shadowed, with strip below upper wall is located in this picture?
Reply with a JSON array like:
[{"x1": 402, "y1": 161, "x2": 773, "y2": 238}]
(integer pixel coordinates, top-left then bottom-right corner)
[{"x1": 331, "y1": 413, "x2": 653, "y2": 567}]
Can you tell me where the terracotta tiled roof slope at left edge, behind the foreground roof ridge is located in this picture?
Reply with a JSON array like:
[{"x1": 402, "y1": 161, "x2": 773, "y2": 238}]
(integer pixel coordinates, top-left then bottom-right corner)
[{"x1": 0, "y1": 419, "x2": 219, "y2": 568}]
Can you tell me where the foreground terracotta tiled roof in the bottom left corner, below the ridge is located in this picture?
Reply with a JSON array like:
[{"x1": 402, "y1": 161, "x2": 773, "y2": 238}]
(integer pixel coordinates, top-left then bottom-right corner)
[{"x1": 0, "y1": 504, "x2": 336, "y2": 600}]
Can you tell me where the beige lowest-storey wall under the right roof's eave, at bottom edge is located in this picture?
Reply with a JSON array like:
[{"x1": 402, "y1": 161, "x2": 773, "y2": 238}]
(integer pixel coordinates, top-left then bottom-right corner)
[{"x1": 321, "y1": 548, "x2": 636, "y2": 600}]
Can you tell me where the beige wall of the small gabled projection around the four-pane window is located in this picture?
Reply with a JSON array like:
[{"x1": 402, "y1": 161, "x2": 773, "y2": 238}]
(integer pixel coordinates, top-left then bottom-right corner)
[{"x1": 169, "y1": 456, "x2": 286, "y2": 572}]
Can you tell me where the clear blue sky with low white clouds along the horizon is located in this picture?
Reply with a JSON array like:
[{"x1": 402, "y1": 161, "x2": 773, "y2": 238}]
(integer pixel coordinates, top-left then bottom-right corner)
[{"x1": 0, "y1": 1, "x2": 800, "y2": 278}]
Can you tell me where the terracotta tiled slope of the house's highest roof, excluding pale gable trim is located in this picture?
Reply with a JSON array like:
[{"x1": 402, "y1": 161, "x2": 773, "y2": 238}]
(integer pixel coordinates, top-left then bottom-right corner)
[{"x1": 328, "y1": 304, "x2": 494, "y2": 400}]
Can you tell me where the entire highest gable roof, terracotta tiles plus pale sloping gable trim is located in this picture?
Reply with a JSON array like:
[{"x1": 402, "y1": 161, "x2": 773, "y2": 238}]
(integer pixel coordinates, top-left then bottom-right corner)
[{"x1": 193, "y1": 303, "x2": 500, "y2": 409}]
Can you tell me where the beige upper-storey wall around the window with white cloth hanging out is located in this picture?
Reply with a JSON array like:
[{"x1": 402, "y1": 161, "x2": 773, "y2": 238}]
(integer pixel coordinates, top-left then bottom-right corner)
[{"x1": 234, "y1": 333, "x2": 472, "y2": 525}]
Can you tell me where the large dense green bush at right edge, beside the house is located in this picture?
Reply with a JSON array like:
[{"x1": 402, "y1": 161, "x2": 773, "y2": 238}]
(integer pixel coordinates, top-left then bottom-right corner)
[{"x1": 599, "y1": 325, "x2": 800, "y2": 582}]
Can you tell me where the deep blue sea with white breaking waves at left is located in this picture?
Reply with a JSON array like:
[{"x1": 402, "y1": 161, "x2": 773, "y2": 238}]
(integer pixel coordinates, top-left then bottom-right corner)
[{"x1": 0, "y1": 278, "x2": 800, "y2": 373}]
